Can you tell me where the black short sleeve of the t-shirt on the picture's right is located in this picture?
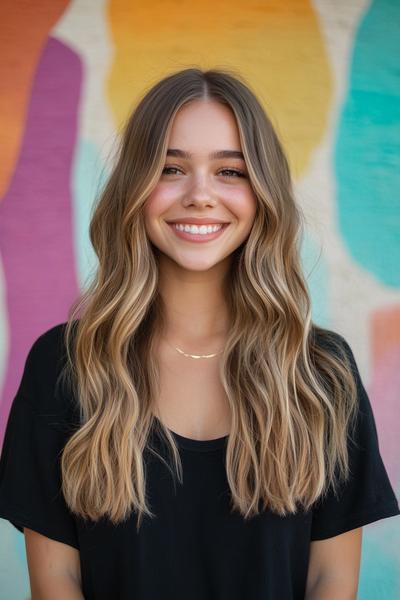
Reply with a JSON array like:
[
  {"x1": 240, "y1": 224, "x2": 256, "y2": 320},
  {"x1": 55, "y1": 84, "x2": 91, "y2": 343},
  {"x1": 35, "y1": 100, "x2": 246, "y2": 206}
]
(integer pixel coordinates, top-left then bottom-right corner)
[{"x1": 311, "y1": 334, "x2": 400, "y2": 541}]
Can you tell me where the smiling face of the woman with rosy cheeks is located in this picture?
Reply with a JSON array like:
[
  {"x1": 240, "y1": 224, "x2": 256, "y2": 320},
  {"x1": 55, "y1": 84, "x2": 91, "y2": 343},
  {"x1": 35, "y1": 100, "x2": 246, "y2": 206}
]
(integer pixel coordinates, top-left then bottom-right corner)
[{"x1": 144, "y1": 100, "x2": 257, "y2": 271}]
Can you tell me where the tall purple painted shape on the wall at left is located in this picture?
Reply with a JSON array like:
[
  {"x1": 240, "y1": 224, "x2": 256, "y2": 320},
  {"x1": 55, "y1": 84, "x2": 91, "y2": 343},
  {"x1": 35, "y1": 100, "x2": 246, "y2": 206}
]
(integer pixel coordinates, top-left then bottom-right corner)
[{"x1": 0, "y1": 37, "x2": 82, "y2": 443}]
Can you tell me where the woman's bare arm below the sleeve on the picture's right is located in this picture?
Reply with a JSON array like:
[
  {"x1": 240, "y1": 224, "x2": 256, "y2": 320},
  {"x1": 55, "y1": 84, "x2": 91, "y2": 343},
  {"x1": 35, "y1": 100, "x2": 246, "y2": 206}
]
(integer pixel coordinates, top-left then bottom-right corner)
[{"x1": 305, "y1": 527, "x2": 362, "y2": 600}]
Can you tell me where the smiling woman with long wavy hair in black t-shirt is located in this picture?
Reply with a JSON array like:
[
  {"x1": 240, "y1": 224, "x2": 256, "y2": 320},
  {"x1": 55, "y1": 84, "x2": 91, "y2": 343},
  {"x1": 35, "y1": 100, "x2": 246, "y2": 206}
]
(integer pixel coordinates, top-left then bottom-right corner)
[{"x1": 0, "y1": 69, "x2": 400, "y2": 600}]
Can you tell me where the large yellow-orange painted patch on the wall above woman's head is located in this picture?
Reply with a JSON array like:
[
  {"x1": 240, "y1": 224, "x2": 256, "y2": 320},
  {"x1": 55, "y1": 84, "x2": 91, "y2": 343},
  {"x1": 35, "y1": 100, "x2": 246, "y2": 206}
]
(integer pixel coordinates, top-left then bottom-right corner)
[{"x1": 107, "y1": 0, "x2": 332, "y2": 175}]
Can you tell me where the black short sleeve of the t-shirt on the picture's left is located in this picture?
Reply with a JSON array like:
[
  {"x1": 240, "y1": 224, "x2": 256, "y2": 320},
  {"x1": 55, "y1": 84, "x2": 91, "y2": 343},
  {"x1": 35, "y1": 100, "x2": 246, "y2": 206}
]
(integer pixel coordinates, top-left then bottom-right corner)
[{"x1": 0, "y1": 328, "x2": 79, "y2": 548}]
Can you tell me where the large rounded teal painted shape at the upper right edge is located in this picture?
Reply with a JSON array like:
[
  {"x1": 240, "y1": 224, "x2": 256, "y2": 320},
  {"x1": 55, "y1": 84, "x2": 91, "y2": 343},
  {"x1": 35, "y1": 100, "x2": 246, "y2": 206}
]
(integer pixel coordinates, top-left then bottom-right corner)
[{"x1": 334, "y1": 0, "x2": 400, "y2": 288}]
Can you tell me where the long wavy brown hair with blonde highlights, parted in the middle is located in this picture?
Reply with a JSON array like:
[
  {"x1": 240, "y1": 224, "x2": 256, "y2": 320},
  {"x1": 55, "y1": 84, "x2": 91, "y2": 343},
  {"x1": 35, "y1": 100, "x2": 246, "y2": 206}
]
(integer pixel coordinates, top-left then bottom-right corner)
[{"x1": 61, "y1": 68, "x2": 357, "y2": 528}]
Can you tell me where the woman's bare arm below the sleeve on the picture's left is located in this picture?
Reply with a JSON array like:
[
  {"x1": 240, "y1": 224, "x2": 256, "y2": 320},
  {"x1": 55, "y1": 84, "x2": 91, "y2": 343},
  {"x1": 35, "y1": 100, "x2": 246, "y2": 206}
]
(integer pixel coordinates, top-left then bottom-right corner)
[{"x1": 24, "y1": 527, "x2": 84, "y2": 600}]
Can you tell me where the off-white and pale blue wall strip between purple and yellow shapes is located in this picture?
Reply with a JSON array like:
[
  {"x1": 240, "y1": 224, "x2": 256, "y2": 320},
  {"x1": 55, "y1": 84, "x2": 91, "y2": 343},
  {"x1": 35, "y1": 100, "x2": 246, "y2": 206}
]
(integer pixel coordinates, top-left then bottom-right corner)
[{"x1": 51, "y1": 0, "x2": 118, "y2": 289}]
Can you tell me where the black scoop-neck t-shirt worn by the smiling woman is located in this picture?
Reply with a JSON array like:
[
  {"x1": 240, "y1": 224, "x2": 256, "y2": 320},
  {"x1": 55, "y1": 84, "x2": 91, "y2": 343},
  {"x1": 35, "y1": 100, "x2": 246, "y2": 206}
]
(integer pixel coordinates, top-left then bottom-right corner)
[{"x1": 0, "y1": 323, "x2": 400, "y2": 600}]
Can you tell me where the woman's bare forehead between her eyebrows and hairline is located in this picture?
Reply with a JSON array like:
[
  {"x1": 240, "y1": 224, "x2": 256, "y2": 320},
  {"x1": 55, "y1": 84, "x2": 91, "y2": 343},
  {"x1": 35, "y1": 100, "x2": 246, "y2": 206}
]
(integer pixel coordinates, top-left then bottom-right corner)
[{"x1": 168, "y1": 100, "x2": 241, "y2": 153}]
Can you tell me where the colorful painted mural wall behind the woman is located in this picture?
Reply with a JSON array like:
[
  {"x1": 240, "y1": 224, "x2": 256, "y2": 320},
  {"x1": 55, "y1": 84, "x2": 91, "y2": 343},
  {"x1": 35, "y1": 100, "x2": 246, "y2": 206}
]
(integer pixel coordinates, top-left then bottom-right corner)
[{"x1": 0, "y1": 0, "x2": 400, "y2": 600}]
